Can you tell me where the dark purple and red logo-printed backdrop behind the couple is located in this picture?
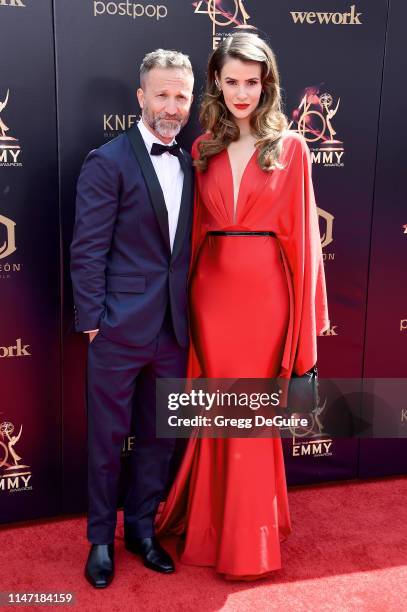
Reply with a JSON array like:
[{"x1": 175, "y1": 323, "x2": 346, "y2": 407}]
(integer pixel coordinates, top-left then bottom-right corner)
[{"x1": 0, "y1": 0, "x2": 407, "y2": 522}]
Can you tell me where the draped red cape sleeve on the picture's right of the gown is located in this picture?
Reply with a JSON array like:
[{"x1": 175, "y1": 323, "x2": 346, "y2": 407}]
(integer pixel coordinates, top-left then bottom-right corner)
[{"x1": 278, "y1": 135, "x2": 329, "y2": 376}]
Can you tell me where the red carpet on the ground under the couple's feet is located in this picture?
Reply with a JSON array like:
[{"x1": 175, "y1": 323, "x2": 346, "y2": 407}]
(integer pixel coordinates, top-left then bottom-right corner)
[{"x1": 0, "y1": 478, "x2": 407, "y2": 612}]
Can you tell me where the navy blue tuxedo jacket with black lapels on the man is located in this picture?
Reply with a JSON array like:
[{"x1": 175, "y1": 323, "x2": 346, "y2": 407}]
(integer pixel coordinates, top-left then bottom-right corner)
[{"x1": 71, "y1": 126, "x2": 193, "y2": 346}]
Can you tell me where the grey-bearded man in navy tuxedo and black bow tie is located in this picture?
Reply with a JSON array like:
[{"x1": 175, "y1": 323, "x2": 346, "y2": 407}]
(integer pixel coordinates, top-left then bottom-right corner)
[{"x1": 71, "y1": 49, "x2": 194, "y2": 588}]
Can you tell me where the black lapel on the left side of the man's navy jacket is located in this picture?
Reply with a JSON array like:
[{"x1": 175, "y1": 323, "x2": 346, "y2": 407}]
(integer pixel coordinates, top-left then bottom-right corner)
[{"x1": 127, "y1": 125, "x2": 171, "y2": 252}]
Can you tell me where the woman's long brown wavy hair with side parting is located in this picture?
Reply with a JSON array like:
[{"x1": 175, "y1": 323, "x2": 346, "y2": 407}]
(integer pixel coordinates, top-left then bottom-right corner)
[{"x1": 194, "y1": 32, "x2": 287, "y2": 172}]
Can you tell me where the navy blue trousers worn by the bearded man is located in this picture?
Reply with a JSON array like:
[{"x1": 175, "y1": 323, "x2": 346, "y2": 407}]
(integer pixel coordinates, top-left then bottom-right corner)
[{"x1": 87, "y1": 312, "x2": 187, "y2": 544}]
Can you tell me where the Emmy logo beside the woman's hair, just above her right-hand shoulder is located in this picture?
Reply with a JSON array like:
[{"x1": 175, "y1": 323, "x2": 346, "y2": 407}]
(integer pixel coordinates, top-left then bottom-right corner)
[{"x1": 288, "y1": 87, "x2": 344, "y2": 166}]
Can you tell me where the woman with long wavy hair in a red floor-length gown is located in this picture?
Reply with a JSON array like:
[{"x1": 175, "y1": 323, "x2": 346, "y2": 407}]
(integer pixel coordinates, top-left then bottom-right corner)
[{"x1": 157, "y1": 33, "x2": 329, "y2": 579}]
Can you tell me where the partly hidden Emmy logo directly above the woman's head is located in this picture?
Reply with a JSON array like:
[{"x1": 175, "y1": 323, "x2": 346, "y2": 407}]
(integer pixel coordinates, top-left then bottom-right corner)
[{"x1": 193, "y1": 0, "x2": 257, "y2": 49}]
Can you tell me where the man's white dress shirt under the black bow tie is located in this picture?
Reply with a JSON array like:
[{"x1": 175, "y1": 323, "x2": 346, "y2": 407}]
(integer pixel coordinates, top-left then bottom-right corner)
[{"x1": 84, "y1": 120, "x2": 184, "y2": 334}]
